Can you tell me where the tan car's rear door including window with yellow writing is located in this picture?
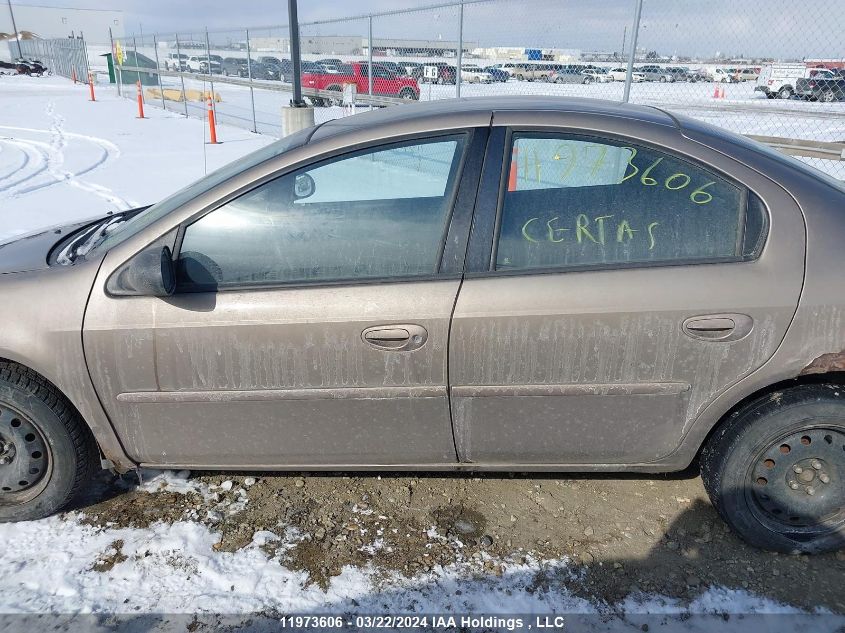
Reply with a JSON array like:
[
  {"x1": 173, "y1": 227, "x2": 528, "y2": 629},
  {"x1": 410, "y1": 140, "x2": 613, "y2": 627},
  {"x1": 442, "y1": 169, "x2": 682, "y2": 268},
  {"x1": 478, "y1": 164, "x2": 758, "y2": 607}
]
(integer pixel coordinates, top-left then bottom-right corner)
[{"x1": 449, "y1": 118, "x2": 804, "y2": 465}]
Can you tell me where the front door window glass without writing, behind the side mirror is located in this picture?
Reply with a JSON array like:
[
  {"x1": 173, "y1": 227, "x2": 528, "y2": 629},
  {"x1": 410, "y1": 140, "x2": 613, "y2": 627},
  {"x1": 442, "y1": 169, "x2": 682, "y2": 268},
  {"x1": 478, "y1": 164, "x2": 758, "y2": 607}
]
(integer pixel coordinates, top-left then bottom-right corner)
[{"x1": 179, "y1": 135, "x2": 465, "y2": 290}]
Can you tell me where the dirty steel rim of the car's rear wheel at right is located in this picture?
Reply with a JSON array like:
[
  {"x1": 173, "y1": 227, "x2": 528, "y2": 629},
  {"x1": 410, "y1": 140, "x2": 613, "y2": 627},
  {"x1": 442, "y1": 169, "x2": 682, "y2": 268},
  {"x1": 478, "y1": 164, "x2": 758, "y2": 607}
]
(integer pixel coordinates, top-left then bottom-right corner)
[{"x1": 744, "y1": 421, "x2": 845, "y2": 540}]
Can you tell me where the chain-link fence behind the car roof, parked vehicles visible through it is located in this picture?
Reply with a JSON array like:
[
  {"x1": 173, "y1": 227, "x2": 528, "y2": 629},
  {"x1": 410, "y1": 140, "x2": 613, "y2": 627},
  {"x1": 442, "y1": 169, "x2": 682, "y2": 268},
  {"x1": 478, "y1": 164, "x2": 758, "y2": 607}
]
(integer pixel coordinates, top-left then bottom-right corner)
[{"x1": 105, "y1": 0, "x2": 845, "y2": 179}]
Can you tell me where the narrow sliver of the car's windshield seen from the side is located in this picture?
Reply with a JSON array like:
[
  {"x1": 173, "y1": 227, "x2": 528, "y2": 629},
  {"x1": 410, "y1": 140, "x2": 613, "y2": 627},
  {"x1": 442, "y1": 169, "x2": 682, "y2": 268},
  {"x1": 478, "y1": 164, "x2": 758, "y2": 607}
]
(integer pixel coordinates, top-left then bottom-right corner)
[{"x1": 88, "y1": 128, "x2": 314, "y2": 252}]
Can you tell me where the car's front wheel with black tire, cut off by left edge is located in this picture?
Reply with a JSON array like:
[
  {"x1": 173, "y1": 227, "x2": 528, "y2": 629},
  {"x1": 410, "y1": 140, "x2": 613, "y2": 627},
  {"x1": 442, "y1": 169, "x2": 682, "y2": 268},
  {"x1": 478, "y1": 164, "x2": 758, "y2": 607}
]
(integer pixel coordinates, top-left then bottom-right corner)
[{"x1": 0, "y1": 361, "x2": 99, "y2": 523}]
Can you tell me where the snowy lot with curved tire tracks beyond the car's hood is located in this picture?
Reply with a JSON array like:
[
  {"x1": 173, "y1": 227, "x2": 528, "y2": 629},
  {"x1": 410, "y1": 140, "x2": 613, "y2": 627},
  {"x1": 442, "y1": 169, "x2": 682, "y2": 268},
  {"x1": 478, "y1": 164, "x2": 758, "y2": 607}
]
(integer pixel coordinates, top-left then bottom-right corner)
[{"x1": 0, "y1": 76, "x2": 274, "y2": 239}]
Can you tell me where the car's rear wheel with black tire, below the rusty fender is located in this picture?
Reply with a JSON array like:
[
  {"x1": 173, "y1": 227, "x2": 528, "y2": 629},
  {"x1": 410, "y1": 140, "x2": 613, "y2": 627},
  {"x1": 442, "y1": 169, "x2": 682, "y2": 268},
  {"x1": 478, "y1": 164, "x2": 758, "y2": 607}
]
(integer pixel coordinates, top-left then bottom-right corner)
[{"x1": 700, "y1": 385, "x2": 845, "y2": 553}]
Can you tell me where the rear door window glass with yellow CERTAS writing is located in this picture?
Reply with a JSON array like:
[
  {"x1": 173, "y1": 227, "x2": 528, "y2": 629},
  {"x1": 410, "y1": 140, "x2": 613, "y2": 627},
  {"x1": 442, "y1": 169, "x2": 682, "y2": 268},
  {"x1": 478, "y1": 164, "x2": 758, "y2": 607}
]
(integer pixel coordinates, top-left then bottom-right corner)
[{"x1": 496, "y1": 134, "x2": 765, "y2": 270}]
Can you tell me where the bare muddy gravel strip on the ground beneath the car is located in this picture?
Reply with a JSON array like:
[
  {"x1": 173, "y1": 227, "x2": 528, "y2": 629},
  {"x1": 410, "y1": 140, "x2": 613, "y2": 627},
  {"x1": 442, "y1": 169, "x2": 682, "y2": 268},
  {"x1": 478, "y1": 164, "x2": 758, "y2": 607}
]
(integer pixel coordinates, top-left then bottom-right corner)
[{"x1": 78, "y1": 471, "x2": 845, "y2": 613}]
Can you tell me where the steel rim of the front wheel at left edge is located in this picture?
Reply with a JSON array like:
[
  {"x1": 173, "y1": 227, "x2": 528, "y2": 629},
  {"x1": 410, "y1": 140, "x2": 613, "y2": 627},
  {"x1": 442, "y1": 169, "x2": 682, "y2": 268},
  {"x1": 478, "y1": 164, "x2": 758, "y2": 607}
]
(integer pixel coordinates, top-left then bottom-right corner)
[{"x1": 0, "y1": 402, "x2": 53, "y2": 506}]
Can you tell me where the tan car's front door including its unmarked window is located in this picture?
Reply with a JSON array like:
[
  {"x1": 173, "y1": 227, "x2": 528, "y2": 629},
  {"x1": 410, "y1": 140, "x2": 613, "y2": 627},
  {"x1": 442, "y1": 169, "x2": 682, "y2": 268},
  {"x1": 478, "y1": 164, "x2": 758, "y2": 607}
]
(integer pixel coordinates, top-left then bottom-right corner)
[{"x1": 84, "y1": 129, "x2": 487, "y2": 467}]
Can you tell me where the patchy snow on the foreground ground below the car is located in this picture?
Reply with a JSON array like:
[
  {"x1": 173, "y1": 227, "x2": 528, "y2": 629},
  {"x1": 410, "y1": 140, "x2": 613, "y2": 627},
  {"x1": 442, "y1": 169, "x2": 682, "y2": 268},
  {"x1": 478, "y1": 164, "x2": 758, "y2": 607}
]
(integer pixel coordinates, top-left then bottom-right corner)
[{"x1": 0, "y1": 471, "x2": 845, "y2": 633}]
